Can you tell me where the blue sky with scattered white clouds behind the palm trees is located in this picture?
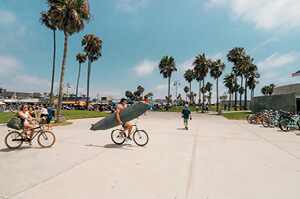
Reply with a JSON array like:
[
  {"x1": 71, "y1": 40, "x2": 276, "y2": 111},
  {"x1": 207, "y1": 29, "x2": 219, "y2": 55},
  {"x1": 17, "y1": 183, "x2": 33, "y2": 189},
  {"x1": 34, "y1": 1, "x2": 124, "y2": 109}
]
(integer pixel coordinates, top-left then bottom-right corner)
[{"x1": 0, "y1": 0, "x2": 300, "y2": 102}]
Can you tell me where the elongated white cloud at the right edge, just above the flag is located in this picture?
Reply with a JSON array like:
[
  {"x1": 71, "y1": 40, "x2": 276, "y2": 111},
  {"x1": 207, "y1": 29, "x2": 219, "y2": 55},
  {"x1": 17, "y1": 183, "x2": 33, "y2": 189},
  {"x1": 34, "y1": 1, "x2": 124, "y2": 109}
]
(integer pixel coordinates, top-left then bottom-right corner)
[{"x1": 257, "y1": 51, "x2": 300, "y2": 70}]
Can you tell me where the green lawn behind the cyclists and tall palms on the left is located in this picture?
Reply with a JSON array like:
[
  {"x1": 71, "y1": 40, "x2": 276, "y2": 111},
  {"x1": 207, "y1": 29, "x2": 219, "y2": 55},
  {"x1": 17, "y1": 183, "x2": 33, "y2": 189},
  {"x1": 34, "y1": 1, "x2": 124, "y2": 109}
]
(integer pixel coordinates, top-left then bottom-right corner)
[{"x1": 0, "y1": 110, "x2": 111, "y2": 123}]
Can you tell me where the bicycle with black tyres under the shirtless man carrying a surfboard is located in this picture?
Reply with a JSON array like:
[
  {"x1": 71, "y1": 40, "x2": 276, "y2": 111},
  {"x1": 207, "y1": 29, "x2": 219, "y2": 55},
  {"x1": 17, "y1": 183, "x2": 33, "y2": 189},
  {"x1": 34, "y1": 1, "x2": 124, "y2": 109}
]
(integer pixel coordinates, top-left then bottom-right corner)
[{"x1": 111, "y1": 119, "x2": 149, "y2": 146}]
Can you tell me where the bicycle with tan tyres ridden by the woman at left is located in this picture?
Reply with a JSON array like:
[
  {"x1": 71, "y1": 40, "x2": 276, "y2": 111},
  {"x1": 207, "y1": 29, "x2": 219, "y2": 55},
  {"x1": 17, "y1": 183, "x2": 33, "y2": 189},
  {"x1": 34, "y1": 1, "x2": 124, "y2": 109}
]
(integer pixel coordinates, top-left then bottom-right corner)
[{"x1": 5, "y1": 124, "x2": 55, "y2": 149}]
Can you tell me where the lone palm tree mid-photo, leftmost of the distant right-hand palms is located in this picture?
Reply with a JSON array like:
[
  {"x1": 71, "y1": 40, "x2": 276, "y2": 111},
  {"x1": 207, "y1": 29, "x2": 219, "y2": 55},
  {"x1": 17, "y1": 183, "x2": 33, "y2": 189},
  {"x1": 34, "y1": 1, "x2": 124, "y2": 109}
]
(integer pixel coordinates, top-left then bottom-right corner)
[{"x1": 158, "y1": 55, "x2": 177, "y2": 110}]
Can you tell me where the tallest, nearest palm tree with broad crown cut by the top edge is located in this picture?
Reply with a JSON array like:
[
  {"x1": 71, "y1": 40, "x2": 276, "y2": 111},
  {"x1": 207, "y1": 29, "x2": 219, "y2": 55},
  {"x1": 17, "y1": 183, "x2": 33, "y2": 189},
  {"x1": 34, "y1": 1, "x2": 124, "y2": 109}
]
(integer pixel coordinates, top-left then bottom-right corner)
[{"x1": 46, "y1": 0, "x2": 91, "y2": 122}]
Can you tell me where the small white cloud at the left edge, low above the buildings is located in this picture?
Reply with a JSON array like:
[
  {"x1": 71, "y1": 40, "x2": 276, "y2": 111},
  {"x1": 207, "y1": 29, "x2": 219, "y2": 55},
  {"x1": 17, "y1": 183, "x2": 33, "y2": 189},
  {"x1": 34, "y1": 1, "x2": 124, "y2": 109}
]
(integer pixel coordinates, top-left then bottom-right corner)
[{"x1": 0, "y1": 55, "x2": 23, "y2": 77}]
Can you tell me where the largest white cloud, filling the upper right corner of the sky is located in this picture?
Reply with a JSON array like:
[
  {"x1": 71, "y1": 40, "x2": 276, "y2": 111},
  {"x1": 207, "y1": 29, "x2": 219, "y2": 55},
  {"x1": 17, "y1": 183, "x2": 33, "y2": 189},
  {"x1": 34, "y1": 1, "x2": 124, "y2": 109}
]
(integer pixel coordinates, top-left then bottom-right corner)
[{"x1": 205, "y1": 0, "x2": 300, "y2": 31}]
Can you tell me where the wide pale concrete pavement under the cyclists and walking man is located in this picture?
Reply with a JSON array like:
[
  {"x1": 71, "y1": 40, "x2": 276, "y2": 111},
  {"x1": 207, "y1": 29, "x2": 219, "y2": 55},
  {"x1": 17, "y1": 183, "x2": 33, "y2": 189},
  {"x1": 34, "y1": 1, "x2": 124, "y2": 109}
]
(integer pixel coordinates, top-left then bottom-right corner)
[{"x1": 0, "y1": 112, "x2": 300, "y2": 199}]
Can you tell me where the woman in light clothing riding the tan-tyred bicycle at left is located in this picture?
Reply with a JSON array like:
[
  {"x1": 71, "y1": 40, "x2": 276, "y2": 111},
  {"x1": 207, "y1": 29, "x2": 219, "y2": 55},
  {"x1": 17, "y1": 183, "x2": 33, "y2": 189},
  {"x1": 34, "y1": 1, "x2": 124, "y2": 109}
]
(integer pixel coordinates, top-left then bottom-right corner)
[{"x1": 18, "y1": 104, "x2": 34, "y2": 145}]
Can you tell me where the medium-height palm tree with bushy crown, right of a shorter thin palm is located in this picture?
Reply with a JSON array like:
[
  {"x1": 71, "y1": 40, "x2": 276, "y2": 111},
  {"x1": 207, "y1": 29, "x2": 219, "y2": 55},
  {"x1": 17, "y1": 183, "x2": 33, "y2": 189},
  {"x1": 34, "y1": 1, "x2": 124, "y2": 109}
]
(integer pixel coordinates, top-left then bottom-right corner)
[{"x1": 81, "y1": 34, "x2": 102, "y2": 110}]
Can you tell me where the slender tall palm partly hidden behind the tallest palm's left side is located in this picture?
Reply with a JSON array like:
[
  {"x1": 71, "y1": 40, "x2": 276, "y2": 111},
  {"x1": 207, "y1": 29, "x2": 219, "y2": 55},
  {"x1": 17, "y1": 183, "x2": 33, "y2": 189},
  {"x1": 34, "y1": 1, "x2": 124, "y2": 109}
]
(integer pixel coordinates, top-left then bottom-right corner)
[{"x1": 40, "y1": 11, "x2": 56, "y2": 107}]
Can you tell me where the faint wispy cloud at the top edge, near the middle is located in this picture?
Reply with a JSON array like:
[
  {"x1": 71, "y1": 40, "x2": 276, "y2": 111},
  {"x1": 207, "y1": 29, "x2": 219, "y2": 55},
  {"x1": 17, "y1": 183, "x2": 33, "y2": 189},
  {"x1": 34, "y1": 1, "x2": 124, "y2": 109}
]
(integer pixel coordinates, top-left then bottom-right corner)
[{"x1": 116, "y1": 0, "x2": 149, "y2": 14}]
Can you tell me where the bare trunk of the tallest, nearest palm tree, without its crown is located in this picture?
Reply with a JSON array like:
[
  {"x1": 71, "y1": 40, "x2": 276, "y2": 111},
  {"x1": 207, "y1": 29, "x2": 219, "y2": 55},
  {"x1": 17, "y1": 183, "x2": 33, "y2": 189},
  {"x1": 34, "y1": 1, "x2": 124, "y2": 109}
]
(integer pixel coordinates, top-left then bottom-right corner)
[{"x1": 57, "y1": 32, "x2": 69, "y2": 122}]
